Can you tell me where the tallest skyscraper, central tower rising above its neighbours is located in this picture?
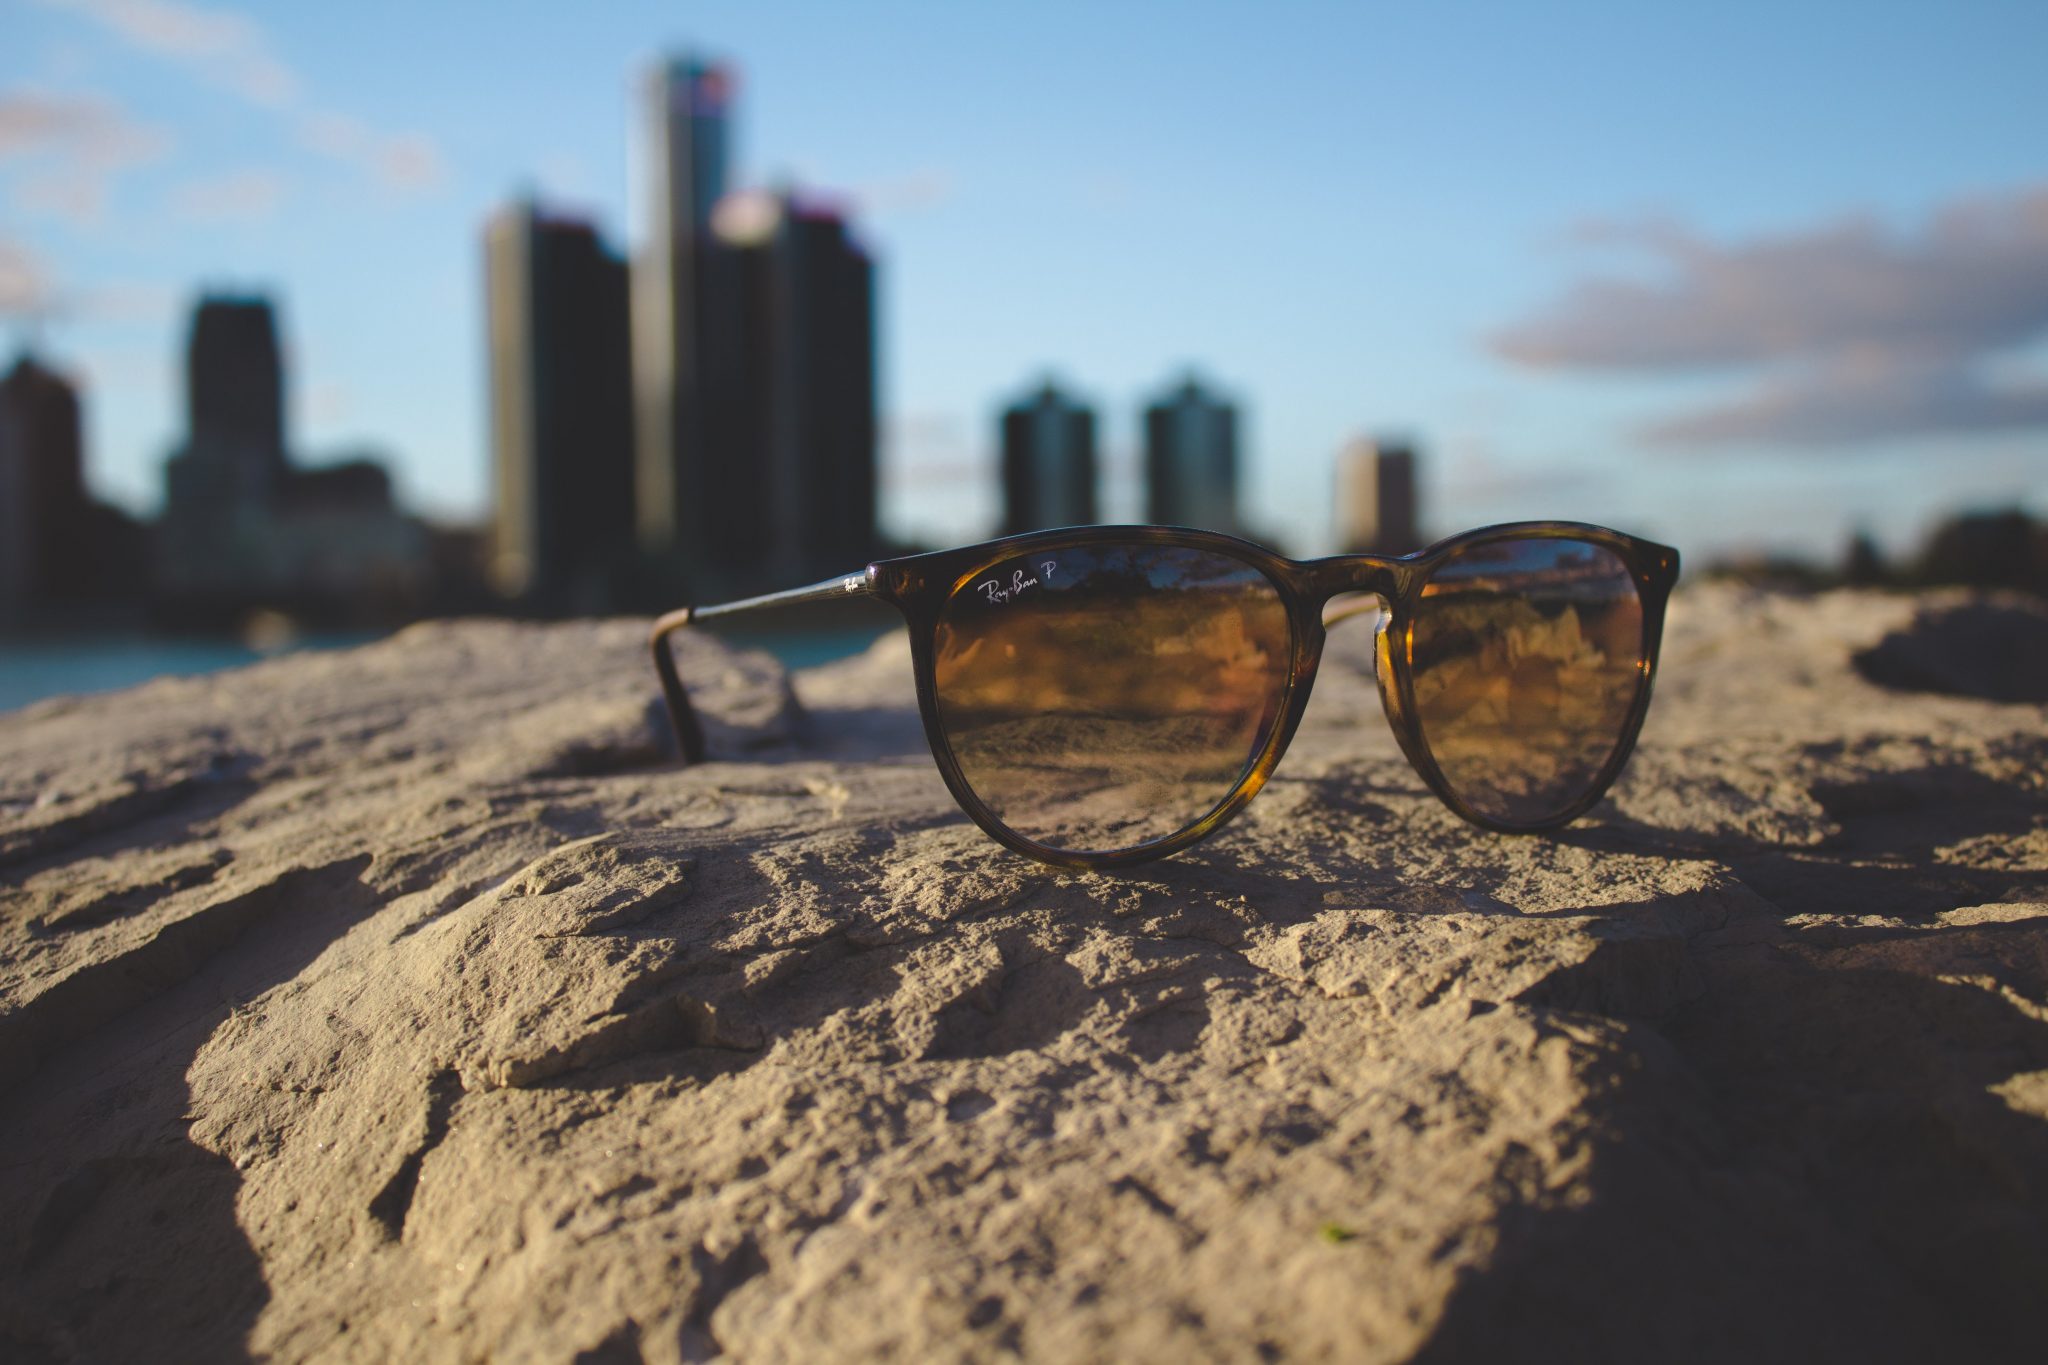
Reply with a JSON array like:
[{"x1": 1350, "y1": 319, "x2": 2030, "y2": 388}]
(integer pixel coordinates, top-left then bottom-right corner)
[{"x1": 633, "y1": 57, "x2": 733, "y2": 559}]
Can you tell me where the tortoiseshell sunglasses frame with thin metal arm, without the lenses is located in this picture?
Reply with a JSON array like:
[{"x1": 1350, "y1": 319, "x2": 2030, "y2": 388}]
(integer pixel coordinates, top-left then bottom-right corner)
[{"x1": 649, "y1": 522, "x2": 1677, "y2": 870}]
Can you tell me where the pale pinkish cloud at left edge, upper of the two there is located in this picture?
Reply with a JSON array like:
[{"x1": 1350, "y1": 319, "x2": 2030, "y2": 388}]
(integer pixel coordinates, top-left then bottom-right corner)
[{"x1": 0, "y1": 90, "x2": 170, "y2": 225}]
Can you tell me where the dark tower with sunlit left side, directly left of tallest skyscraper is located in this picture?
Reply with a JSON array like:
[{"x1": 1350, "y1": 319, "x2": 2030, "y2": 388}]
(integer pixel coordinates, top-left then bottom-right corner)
[{"x1": 483, "y1": 203, "x2": 633, "y2": 610}]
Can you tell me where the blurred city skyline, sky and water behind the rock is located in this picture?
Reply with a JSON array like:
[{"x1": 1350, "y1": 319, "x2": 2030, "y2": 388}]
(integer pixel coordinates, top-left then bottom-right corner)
[{"x1": 0, "y1": 0, "x2": 2048, "y2": 708}]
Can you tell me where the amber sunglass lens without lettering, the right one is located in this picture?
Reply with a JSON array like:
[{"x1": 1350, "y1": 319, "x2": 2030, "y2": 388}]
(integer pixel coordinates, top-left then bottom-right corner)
[{"x1": 1411, "y1": 540, "x2": 1645, "y2": 825}]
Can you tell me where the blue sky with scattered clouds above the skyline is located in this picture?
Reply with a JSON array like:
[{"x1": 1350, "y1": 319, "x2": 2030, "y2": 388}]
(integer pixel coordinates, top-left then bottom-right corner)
[{"x1": 0, "y1": 0, "x2": 2048, "y2": 561}]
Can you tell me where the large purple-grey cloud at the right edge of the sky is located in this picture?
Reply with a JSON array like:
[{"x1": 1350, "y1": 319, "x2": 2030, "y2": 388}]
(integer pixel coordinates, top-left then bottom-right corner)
[{"x1": 1489, "y1": 186, "x2": 2048, "y2": 446}]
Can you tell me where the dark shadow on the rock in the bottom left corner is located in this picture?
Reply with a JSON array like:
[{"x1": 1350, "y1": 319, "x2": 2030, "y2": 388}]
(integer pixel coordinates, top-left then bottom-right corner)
[{"x1": 0, "y1": 857, "x2": 379, "y2": 1361}]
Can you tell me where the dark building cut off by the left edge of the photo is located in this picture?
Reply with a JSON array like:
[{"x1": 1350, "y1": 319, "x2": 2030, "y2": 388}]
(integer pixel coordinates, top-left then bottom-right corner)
[{"x1": 0, "y1": 354, "x2": 92, "y2": 620}]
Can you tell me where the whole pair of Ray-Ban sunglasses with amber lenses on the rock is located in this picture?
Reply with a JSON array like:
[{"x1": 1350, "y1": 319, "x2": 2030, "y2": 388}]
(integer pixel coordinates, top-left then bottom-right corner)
[{"x1": 651, "y1": 522, "x2": 1677, "y2": 868}]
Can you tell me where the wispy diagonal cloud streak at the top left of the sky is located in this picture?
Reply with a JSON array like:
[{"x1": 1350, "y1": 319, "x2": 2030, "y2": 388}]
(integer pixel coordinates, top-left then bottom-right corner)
[{"x1": 37, "y1": 0, "x2": 444, "y2": 190}]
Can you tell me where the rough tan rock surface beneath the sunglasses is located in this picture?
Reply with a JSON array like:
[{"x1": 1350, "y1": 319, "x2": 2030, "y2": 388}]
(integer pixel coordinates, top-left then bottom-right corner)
[{"x1": 0, "y1": 587, "x2": 2048, "y2": 1361}]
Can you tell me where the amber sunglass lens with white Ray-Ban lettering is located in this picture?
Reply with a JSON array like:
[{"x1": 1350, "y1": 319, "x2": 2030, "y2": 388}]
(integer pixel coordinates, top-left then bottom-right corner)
[{"x1": 932, "y1": 544, "x2": 1292, "y2": 853}]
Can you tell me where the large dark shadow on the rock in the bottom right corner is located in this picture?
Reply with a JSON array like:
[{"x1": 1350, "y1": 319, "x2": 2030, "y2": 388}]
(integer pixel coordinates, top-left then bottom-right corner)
[{"x1": 1417, "y1": 896, "x2": 2048, "y2": 1361}]
